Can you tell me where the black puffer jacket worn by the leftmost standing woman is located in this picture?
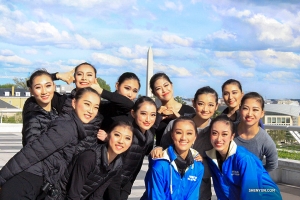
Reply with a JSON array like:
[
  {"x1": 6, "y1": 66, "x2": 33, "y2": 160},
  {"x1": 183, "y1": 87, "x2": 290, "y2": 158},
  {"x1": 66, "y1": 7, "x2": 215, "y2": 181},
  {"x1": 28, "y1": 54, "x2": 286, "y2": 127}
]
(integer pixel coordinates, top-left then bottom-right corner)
[{"x1": 22, "y1": 97, "x2": 58, "y2": 176}]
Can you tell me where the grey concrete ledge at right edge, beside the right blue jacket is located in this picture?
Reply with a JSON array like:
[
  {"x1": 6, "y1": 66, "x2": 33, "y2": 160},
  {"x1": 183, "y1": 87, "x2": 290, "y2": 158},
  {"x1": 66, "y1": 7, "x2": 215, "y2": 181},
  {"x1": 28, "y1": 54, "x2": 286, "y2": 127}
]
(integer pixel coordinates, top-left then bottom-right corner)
[{"x1": 270, "y1": 158, "x2": 300, "y2": 187}]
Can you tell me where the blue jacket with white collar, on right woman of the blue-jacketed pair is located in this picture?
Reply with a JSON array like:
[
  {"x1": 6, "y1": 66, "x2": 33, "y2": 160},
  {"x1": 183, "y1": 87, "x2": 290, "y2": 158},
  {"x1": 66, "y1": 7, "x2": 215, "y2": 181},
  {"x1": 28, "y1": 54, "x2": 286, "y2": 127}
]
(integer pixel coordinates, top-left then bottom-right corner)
[{"x1": 206, "y1": 141, "x2": 282, "y2": 200}]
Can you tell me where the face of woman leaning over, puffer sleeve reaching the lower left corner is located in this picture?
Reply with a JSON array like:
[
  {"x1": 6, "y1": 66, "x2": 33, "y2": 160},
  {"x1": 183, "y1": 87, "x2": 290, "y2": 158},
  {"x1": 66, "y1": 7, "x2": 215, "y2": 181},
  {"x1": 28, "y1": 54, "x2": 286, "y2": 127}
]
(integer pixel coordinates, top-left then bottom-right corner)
[{"x1": 72, "y1": 92, "x2": 100, "y2": 124}]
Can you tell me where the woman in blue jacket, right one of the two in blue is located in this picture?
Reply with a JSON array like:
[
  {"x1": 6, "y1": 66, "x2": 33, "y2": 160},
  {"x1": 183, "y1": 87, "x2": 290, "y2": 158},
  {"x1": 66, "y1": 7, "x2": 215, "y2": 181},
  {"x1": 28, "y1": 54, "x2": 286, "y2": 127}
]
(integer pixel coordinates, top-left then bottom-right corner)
[{"x1": 206, "y1": 115, "x2": 282, "y2": 200}]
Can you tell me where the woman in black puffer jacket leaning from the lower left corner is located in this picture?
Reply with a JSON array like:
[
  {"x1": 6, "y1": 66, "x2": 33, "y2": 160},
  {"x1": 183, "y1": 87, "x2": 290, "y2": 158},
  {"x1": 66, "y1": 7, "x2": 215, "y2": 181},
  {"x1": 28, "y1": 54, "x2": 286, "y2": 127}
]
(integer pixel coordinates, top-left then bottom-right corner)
[{"x1": 0, "y1": 88, "x2": 100, "y2": 199}]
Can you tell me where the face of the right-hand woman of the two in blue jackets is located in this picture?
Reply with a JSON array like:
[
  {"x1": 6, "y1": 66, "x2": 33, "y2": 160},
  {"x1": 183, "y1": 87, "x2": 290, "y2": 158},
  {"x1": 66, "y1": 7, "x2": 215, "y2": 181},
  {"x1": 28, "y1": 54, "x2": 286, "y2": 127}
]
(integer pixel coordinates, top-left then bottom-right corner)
[{"x1": 210, "y1": 121, "x2": 234, "y2": 157}]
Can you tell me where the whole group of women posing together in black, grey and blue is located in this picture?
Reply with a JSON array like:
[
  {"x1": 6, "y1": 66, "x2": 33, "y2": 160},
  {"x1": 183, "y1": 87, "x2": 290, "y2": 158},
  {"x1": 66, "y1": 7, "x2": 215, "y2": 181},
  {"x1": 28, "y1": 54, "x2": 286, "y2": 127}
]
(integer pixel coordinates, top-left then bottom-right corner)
[{"x1": 0, "y1": 63, "x2": 281, "y2": 200}]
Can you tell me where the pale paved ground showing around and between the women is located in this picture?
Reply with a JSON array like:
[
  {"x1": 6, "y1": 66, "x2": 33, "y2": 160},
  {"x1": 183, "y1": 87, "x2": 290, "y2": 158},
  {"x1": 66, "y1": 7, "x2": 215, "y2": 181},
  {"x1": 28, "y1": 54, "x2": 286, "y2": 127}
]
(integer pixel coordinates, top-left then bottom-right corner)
[{"x1": 0, "y1": 126, "x2": 300, "y2": 200}]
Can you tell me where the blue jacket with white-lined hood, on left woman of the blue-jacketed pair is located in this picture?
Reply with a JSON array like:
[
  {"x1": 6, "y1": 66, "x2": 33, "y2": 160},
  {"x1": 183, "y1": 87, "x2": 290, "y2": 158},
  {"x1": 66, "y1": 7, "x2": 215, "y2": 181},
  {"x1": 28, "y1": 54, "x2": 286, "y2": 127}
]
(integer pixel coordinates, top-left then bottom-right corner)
[{"x1": 141, "y1": 146, "x2": 204, "y2": 200}]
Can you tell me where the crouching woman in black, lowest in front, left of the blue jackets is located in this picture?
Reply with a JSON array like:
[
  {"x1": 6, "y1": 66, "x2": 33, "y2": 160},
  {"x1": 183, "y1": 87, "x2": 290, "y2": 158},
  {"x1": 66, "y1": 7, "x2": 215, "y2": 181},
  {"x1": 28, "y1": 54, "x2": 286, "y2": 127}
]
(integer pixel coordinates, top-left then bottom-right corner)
[{"x1": 64, "y1": 121, "x2": 133, "y2": 199}]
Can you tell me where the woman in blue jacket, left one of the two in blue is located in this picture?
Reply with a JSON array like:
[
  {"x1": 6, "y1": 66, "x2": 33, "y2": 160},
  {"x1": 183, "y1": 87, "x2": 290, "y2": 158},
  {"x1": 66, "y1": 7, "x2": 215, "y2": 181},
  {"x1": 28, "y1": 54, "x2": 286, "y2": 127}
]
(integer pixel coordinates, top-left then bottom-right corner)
[{"x1": 141, "y1": 117, "x2": 204, "y2": 200}]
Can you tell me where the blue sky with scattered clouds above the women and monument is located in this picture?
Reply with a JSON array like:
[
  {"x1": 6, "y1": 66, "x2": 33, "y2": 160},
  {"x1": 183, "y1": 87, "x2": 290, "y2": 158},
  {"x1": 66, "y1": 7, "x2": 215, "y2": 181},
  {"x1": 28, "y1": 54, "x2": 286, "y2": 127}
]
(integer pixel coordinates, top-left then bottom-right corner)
[{"x1": 0, "y1": 0, "x2": 300, "y2": 99}]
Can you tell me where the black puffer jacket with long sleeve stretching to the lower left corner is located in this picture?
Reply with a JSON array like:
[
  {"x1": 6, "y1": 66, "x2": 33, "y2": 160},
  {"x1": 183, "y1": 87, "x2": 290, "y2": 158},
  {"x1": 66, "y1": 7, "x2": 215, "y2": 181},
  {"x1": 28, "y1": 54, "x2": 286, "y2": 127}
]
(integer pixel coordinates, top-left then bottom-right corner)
[{"x1": 0, "y1": 112, "x2": 86, "y2": 193}]
